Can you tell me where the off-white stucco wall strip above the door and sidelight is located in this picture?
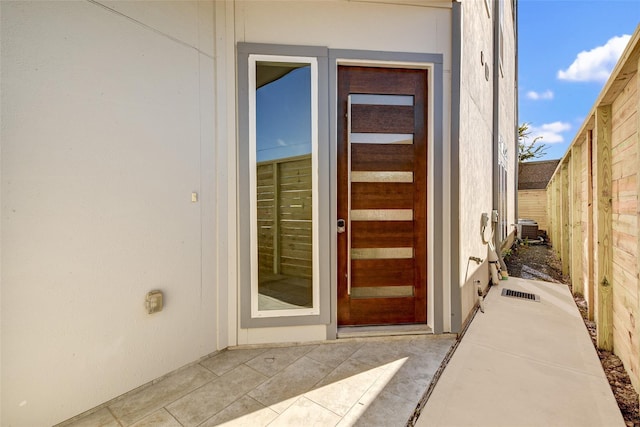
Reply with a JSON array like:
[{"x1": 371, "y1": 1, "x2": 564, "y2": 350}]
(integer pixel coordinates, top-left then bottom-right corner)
[{"x1": 236, "y1": 0, "x2": 451, "y2": 53}]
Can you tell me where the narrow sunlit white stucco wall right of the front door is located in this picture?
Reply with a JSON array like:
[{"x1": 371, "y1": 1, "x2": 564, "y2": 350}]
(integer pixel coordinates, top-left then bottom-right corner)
[{"x1": 460, "y1": 1, "x2": 493, "y2": 321}]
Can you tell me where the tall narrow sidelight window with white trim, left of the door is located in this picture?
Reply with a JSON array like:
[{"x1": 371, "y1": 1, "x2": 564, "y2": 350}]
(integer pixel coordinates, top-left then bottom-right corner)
[{"x1": 248, "y1": 55, "x2": 319, "y2": 318}]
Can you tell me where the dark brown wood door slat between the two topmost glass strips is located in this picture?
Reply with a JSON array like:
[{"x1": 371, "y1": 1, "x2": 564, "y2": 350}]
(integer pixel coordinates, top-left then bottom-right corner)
[{"x1": 351, "y1": 104, "x2": 414, "y2": 133}]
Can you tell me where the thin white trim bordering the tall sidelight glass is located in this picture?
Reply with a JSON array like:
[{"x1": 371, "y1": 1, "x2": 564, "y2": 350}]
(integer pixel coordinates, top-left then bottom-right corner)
[{"x1": 248, "y1": 54, "x2": 320, "y2": 318}]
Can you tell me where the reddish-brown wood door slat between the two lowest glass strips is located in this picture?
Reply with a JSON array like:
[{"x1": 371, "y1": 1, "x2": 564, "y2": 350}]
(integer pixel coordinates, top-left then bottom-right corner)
[{"x1": 351, "y1": 259, "x2": 413, "y2": 286}]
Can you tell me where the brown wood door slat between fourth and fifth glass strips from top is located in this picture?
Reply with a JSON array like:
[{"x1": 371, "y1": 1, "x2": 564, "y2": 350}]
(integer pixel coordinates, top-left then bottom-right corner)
[{"x1": 351, "y1": 221, "x2": 413, "y2": 248}]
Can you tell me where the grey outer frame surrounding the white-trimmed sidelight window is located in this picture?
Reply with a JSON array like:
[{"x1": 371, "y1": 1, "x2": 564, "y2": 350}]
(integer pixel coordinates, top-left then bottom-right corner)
[{"x1": 236, "y1": 42, "x2": 334, "y2": 329}]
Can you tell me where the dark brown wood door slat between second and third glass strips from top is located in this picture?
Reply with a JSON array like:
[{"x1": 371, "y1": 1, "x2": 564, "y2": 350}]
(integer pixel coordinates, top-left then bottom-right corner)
[{"x1": 351, "y1": 144, "x2": 414, "y2": 171}]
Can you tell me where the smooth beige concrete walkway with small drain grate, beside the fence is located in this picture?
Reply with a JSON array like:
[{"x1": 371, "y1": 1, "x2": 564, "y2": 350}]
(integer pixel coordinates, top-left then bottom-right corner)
[{"x1": 416, "y1": 278, "x2": 625, "y2": 427}]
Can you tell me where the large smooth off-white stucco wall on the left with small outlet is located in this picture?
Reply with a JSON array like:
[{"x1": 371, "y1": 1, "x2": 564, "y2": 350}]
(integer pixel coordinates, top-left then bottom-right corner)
[{"x1": 0, "y1": 1, "x2": 226, "y2": 426}]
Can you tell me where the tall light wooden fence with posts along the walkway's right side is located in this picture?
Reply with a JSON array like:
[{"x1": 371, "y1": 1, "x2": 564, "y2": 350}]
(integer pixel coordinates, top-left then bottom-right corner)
[{"x1": 547, "y1": 27, "x2": 640, "y2": 390}]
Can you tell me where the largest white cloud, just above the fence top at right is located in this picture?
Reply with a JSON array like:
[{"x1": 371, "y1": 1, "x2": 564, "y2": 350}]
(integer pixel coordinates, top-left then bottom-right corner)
[{"x1": 558, "y1": 34, "x2": 631, "y2": 82}]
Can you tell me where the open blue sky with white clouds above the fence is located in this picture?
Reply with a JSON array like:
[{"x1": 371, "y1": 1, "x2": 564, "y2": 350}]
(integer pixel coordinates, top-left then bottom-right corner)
[{"x1": 518, "y1": 0, "x2": 640, "y2": 160}]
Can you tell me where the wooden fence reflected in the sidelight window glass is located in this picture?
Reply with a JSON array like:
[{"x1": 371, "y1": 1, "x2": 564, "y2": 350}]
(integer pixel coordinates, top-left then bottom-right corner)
[{"x1": 257, "y1": 155, "x2": 312, "y2": 278}]
